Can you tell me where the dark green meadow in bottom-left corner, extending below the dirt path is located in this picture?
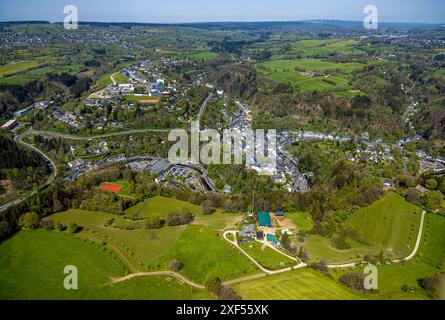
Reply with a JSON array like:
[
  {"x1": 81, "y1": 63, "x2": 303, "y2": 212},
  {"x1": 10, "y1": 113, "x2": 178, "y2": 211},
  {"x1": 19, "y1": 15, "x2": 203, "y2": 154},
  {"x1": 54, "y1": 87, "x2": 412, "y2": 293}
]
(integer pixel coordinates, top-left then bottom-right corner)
[{"x1": 0, "y1": 231, "x2": 211, "y2": 300}]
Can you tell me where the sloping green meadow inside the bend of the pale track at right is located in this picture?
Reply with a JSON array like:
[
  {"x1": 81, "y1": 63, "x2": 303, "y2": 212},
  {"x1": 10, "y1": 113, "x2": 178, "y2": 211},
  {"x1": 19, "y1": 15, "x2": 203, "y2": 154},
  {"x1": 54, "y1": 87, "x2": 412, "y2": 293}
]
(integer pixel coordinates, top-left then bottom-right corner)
[{"x1": 306, "y1": 193, "x2": 422, "y2": 263}]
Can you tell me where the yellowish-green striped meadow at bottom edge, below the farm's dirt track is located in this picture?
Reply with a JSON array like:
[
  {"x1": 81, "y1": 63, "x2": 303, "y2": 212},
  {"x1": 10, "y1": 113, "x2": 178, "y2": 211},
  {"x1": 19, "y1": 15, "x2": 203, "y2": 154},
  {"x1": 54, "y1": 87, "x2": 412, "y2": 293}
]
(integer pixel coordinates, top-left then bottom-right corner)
[{"x1": 234, "y1": 269, "x2": 363, "y2": 300}]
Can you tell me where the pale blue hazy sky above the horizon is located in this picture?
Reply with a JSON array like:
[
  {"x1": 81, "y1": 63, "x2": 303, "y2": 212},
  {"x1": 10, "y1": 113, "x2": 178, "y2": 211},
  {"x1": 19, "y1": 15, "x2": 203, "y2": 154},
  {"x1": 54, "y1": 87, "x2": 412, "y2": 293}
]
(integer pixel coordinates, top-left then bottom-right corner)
[{"x1": 0, "y1": 0, "x2": 445, "y2": 23}]
